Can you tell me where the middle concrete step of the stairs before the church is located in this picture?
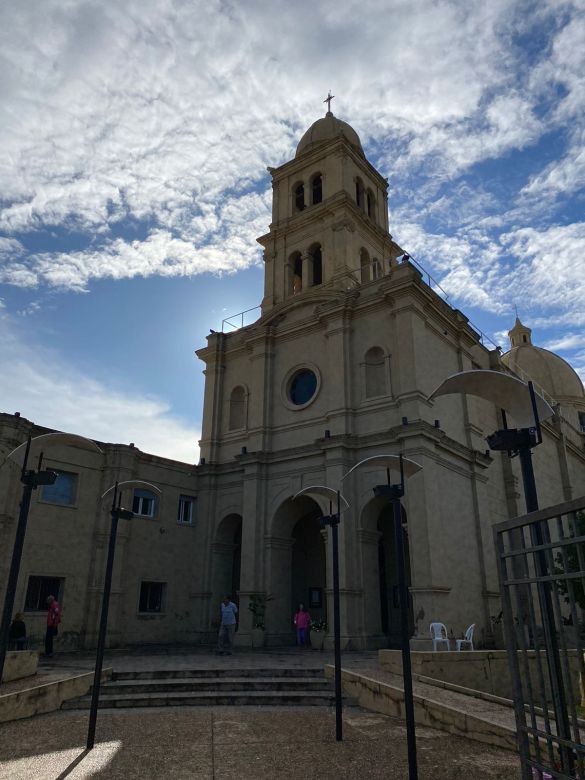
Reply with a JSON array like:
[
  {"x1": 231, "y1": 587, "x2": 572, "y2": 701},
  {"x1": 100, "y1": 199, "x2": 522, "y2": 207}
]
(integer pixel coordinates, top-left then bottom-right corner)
[{"x1": 101, "y1": 675, "x2": 331, "y2": 696}]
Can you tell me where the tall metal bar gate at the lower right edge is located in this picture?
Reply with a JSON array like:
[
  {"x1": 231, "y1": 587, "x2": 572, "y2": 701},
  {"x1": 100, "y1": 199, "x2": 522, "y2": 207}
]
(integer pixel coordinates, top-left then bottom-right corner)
[{"x1": 494, "y1": 496, "x2": 585, "y2": 780}]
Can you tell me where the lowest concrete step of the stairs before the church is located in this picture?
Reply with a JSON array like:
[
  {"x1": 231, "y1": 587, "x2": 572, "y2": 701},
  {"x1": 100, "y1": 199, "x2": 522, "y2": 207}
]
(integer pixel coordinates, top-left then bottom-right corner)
[{"x1": 62, "y1": 691, "x2": 335, "y2": 710}]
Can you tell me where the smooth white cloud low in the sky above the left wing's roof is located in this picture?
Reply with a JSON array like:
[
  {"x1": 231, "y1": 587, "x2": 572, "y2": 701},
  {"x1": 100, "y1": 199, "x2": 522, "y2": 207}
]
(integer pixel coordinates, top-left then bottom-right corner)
[{"x1": 0, "y1": 319, "x2": 200, "y2": 463}]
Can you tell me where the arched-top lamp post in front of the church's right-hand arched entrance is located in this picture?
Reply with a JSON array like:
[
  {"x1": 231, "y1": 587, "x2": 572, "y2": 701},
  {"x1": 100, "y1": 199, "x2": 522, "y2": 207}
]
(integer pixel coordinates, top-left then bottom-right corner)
[{"x1": 341, "y1": 455, "x2": 422, "y2": 780}]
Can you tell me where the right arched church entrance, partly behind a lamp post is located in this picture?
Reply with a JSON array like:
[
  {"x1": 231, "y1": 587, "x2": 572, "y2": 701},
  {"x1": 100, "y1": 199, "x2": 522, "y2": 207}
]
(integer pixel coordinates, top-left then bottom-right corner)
[{"x1": 362, "y1": 499, "x2": 414, "y2": 648}]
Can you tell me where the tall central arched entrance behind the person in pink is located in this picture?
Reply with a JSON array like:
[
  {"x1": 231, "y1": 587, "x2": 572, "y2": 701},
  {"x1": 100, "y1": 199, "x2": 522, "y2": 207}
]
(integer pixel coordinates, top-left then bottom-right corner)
[{"x1": 266, "y1": 496, "x2": 327, "y2": 645}]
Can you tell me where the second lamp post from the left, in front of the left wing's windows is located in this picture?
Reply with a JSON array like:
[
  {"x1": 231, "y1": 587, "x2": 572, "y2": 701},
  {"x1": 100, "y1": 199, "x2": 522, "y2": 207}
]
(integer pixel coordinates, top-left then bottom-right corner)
[{"x1": 86, "y1": 479, "x2": 161, "y2": 750}]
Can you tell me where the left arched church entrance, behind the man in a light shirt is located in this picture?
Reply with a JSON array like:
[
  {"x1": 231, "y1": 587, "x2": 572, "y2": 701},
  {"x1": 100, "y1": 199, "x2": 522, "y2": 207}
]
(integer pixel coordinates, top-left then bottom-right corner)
[{"x1": 211, "y1": 514, "x2": 242, "y2": 623}]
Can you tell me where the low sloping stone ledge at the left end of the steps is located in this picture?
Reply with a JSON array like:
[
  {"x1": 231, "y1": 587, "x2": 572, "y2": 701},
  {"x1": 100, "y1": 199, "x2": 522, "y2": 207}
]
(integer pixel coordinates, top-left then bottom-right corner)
[{"x1": 0, "y1": 667, "x2": 112, "y2": 723}]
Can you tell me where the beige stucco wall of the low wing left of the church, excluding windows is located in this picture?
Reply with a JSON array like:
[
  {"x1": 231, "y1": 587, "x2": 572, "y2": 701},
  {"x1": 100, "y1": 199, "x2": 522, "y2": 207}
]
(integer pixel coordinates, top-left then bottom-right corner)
[{"x1": 0, "y1": 414, "x2": 205, "y2": 650}]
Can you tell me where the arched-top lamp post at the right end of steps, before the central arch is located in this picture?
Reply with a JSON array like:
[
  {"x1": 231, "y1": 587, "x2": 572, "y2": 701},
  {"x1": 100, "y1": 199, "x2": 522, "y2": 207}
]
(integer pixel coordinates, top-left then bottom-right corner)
[{"x1": 293, "y1": 485, "x2": 349, "y2": 742}]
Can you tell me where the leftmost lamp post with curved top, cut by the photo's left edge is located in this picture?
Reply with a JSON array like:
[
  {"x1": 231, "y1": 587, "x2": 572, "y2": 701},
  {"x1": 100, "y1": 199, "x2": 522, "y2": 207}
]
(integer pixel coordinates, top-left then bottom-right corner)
[{"x1": 0, "y1": 433, "x2": 102, "y2": 682}]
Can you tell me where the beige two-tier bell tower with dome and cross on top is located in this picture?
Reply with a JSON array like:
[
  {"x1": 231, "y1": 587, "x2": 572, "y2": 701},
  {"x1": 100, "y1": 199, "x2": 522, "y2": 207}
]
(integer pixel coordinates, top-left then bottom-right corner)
[{"x1": 258, "y1": 98, "x2": 402, "y2": 314}]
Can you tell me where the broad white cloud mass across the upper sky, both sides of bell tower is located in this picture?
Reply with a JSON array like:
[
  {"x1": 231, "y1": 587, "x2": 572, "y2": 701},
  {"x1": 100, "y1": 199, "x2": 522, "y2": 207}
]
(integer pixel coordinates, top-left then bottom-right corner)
[{"x1": 0, "y1": 0, "x2": 585, "y2": 360}]
